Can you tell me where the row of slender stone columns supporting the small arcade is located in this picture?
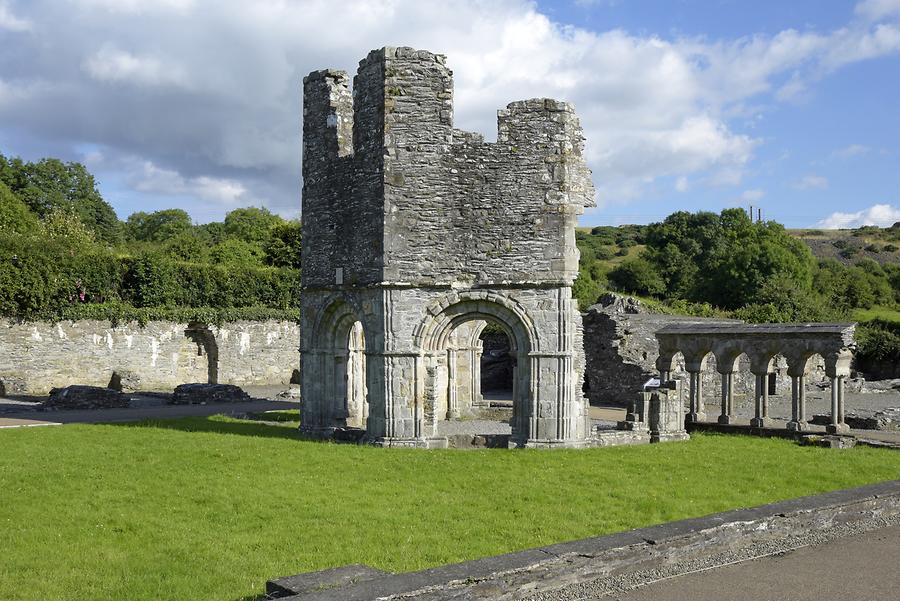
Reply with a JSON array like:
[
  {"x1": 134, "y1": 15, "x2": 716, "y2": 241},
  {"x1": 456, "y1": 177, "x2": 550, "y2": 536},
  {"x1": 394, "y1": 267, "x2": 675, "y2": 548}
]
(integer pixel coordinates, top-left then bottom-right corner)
[{"x1": 684, "y1": 369, "x2": 849, "y2": 434}]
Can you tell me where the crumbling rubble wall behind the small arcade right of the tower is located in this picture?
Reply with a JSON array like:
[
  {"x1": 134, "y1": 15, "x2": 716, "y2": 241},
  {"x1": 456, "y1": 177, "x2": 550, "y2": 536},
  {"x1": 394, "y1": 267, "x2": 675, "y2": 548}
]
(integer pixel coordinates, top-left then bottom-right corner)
[{"x1": 584, "y1": 294, "x2": 826, "y2": 405}]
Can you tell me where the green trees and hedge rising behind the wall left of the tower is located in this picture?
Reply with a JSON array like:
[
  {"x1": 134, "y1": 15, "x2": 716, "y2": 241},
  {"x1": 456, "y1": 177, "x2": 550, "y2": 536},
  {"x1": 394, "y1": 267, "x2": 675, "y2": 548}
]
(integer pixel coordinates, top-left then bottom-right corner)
[{"x1": 0, "y1": 154, "x2": 301, "y2": 320}]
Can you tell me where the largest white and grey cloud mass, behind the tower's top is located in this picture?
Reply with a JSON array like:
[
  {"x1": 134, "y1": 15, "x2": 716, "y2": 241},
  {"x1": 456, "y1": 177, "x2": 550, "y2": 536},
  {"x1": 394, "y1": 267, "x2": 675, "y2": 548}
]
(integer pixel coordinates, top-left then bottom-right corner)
[{"x1": 0, "y1": 0, "x2": 900, "y2": 220}]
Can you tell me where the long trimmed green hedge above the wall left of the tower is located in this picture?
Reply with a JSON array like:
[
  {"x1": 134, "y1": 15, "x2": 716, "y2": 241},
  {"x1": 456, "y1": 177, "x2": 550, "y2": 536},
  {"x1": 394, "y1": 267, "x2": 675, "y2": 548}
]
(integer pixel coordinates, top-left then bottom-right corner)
[{"x1": 0, "y1": 235, "x2": 300, "y2": 321}]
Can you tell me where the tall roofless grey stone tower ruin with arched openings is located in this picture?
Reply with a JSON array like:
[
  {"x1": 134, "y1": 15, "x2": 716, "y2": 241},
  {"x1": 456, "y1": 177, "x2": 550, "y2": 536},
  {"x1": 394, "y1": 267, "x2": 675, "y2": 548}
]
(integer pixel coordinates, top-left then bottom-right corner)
[{"x1": 300, "y1": 48, "x2": 594, "y2": 447}]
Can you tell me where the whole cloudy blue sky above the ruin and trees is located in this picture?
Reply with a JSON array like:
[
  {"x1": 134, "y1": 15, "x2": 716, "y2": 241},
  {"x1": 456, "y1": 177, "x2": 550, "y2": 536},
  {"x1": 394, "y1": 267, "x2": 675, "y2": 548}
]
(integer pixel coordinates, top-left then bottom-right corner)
[{"x1": 0, "y1": 0, "x2": 900, "y2": 227}]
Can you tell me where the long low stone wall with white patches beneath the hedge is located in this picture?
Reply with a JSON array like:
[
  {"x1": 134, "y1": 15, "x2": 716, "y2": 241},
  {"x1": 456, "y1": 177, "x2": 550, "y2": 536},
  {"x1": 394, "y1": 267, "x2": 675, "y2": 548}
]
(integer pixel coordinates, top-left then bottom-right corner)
[{"x1": 0, "y1": 320, "x2": 300, "y2": 394}]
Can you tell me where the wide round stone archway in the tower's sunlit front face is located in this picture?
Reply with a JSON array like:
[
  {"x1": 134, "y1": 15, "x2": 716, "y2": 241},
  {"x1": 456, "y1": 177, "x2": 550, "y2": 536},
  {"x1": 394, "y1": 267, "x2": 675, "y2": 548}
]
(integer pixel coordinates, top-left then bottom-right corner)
[{"x1": 416, "y1": 295, "x2": 537, "y2": 444}]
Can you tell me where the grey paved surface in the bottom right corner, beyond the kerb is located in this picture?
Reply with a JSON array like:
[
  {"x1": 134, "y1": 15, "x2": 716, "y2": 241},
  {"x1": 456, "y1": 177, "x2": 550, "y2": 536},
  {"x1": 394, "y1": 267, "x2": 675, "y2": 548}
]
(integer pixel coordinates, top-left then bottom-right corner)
[{"x1": 594, "y1": 526, "x2": 900, "y2": 601}]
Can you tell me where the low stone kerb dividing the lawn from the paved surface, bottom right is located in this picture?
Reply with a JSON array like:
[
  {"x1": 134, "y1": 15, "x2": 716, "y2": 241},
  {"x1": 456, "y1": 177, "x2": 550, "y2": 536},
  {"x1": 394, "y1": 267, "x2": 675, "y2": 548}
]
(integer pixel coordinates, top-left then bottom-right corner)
[{"x1": 273, "y1": 480, "x2": 900, "y2": 601}]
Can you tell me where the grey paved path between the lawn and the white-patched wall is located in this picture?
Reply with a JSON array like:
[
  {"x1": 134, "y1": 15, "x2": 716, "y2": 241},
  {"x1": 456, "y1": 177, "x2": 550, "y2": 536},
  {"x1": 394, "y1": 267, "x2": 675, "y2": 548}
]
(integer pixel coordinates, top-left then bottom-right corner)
[{"x1": 0, "y1": 400, "x2": 299, "y2": 428}]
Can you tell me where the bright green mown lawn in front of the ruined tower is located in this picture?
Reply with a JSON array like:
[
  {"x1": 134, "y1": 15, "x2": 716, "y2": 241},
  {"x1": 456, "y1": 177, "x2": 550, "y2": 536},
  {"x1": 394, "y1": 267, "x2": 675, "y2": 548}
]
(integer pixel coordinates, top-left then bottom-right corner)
[{"x1": 0, "y1": 417, "x2": 900, "y2": 601}]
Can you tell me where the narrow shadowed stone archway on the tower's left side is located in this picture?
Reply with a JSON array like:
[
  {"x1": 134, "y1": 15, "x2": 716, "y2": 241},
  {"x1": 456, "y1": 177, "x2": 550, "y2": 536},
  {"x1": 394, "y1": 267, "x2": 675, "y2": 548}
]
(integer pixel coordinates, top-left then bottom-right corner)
[{"x1": 301, "y1": 298, "x2": 369, "y2": 431}]
